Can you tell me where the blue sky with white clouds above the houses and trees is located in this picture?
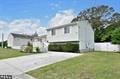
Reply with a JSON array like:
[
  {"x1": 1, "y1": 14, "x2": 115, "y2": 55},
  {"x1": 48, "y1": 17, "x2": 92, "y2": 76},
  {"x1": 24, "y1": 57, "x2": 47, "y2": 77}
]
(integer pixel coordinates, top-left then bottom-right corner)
[{"x1": 0, "y1": 0, "x2": 120, "y2": 40}]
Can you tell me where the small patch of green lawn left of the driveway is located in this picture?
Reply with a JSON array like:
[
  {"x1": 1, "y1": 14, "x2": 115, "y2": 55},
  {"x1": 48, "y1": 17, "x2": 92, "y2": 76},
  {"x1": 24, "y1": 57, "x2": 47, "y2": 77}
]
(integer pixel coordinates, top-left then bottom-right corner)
[{"x1": 0, "y1": 48, "x2": 29, "y2": 59}]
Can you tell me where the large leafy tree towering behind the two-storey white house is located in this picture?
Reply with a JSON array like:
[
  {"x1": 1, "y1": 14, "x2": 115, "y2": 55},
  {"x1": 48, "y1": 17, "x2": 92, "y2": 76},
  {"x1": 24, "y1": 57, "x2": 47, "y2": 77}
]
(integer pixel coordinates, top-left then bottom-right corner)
[{"x1": 72, "y1": 5, "x2": 120, "y2": 42}]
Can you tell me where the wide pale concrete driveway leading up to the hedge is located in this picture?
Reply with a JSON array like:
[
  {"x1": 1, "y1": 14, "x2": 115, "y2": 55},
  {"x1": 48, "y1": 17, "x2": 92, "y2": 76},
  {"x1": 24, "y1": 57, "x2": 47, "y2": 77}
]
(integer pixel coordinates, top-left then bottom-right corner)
[{"x1": 0, "y1": 52, "x2": 81, "y2": 79}]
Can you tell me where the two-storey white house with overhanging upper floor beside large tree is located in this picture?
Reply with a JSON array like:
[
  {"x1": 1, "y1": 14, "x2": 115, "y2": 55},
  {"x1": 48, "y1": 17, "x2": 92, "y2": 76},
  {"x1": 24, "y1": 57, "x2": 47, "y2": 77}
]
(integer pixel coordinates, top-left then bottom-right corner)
[{"x1": 47, "y1": 21, "x2": 94, "y2": 52}]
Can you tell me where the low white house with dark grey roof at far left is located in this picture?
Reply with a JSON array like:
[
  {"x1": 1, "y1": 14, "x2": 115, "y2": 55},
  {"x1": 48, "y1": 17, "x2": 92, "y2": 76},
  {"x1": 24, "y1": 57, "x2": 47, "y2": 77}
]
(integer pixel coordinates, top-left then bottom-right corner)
[{"x1": 8, "y1": 33, "x2": 33, "y2": 49}]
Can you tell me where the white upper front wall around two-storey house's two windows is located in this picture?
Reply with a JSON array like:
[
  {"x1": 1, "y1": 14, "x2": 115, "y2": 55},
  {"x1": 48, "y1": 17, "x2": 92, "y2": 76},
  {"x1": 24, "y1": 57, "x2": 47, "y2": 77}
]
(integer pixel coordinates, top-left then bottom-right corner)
[{"x1": 47, "y1": 25, "x2": 78, "y2": 42}]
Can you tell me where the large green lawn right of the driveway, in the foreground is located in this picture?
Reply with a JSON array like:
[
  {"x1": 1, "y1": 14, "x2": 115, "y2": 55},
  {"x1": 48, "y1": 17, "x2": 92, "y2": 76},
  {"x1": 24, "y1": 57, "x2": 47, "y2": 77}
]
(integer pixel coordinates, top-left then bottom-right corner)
[{"x1": 28, "y1": 52, "x2": 120, "y2": 79}]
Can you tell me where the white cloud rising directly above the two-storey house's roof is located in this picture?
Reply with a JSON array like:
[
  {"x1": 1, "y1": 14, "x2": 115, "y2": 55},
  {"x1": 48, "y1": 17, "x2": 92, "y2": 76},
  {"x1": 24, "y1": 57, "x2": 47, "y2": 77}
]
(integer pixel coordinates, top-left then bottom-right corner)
[{"x1": 49, "y1": 9, "x2": 75, "y2": 27}]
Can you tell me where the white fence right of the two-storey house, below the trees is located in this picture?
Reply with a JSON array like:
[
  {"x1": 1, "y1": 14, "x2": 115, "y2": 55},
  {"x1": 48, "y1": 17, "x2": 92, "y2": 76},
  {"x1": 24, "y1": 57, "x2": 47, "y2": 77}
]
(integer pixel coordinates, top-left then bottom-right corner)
[{"x1": 95, "y1": 42, "x2": 120, "y2": 52}]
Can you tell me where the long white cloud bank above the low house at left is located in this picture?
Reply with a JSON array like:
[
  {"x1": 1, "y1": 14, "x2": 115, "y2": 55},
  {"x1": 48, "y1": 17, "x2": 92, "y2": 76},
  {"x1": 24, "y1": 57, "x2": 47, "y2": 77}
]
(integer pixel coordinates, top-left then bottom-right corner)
[{"x1": 0, "y1": 19, "x2": 46, "y2": 40}]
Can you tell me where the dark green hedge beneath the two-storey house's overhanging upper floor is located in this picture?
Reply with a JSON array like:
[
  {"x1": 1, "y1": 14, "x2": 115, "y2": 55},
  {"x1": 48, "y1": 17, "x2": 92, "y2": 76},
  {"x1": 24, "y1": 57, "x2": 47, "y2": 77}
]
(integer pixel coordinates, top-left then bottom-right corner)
[{"x1": 48, "y1": 43, "x2": 79, "y2": 52}]
